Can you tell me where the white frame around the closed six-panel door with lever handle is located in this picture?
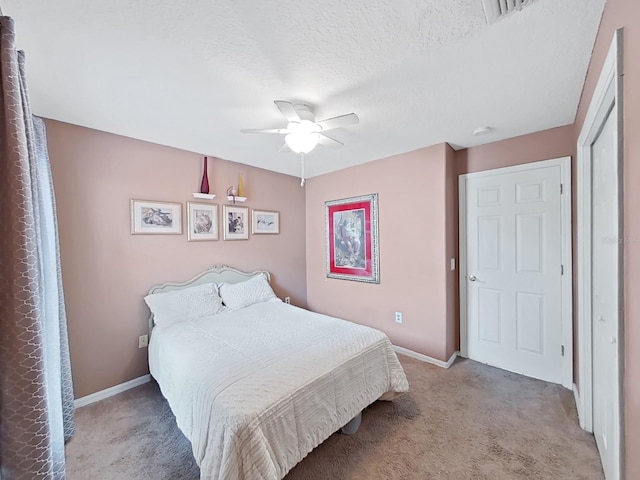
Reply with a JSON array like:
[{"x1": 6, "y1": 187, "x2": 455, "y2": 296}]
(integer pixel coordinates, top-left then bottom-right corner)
[{"x1": 458, "y1": 157, "x2": 573, "y2": 389}]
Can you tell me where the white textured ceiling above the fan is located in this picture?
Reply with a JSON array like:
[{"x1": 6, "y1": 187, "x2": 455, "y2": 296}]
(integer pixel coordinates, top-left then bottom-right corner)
[{"x1": 0, "y1": 0, "x2": 605, "y2": 176}]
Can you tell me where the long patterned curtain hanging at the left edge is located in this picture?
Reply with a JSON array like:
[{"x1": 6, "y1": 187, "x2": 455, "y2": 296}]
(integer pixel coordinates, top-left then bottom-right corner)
[{"x1": 0, "y1": 17, "x2": 74, "y2": 480}]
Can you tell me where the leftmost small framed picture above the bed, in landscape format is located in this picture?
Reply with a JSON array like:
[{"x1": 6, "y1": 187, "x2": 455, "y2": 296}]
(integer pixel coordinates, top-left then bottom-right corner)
[{"x1": 131, "y1": 199, "x2": 182, "y2": 235}]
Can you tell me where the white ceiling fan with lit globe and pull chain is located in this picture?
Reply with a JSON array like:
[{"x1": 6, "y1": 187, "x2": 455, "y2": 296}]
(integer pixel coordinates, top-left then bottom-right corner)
[{"x1": 240, "y1": 100, "x2": 360, "y2": 185}]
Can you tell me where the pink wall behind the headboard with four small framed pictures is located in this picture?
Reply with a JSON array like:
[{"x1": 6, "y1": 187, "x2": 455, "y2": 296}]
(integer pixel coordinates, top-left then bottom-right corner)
[{"x1": 46, "y1": 120, "x2": 306, "y2": 397}]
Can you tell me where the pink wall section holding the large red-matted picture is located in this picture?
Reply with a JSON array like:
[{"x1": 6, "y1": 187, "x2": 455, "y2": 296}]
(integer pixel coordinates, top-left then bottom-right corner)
[{"x1": 306, "y1": 144, "x2": 448, "y2": 360}]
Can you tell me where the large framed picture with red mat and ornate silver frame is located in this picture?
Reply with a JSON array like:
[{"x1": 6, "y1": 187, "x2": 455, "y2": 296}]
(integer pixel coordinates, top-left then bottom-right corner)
[{"x1": 325, "y1": 193, "x2": 380, "y2": 283}]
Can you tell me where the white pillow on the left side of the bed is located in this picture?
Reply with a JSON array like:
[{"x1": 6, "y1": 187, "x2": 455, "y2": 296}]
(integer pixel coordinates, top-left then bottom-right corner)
[{"x1": 144, "y1": 283, "x2": 225, "y2": 325}]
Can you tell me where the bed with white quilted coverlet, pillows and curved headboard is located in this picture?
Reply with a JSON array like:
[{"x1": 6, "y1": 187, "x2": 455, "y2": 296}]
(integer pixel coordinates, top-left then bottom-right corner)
[{"x1": 145, "y1": 266, "x2": 409, "y2": 480}]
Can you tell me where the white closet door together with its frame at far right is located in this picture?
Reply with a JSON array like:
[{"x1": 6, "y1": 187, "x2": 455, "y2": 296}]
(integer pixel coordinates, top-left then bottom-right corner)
[{"x1": 574, "y1": 29, "x2": 625, "y2": 480}]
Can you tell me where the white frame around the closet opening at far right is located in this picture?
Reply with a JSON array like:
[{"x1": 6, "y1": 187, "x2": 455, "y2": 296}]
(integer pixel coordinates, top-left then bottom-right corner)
[{"x1": 574, "y1": 29, "x2": 624, "y2": 478}]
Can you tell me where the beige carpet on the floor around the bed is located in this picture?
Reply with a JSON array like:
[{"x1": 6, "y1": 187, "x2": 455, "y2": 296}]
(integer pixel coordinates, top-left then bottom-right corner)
[{"x1": 67, "y1": 356, "x2": 603, "y2": 480}]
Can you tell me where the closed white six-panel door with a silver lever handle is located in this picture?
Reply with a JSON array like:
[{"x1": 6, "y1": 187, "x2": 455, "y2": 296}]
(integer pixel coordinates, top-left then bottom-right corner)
[{"x1": 461, "y1": 162, "x2": 564, "y2": 383}]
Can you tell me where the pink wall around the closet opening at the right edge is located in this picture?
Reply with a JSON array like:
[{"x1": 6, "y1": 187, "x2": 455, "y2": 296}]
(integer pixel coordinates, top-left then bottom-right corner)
[{"x1": 576, "y1": 0, "x2": 640, "y2": 479}]
